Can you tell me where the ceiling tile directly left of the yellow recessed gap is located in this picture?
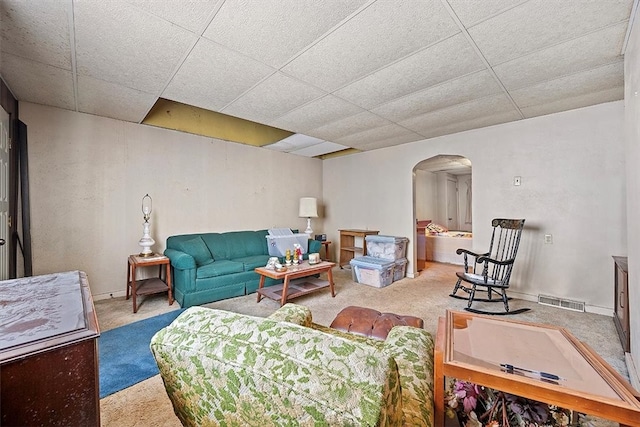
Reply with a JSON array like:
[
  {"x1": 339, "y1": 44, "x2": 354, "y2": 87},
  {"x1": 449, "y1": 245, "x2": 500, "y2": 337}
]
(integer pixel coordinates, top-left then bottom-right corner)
[{"x1": 78, "y1": 76, "x2": 157, "y2": 123}]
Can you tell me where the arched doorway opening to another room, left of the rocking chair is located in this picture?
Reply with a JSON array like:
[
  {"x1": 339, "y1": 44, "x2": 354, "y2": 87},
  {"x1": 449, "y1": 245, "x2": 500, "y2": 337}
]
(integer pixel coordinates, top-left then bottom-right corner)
[{"x1": 413, "y1": 154, "x2": 473, "y2": 272}]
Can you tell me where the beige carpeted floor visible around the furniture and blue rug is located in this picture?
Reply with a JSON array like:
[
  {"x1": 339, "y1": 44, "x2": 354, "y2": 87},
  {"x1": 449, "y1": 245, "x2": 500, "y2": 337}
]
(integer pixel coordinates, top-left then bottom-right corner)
[{"x1": 95, "y1": 263, "x2": 628, "y2": 427}]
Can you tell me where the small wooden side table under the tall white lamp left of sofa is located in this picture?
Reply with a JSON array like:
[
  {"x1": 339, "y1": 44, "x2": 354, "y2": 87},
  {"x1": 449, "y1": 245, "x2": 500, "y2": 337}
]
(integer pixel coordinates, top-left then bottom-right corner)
[{"x1": 126, "y1": 255, "x2": 173, "y2": 313}]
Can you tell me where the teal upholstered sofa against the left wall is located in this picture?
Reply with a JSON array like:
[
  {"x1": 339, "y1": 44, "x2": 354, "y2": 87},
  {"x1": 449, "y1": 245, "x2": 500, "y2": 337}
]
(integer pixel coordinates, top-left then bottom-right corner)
[{"x1": 164, "y1": 230, "x2": 321, "y2": 308}]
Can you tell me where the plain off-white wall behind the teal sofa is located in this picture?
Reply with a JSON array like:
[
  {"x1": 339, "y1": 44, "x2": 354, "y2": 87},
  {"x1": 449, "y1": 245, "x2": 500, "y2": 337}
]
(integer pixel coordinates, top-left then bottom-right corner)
[{"x1": 20, "y1": 103, "x2": 322, "y2": 299}]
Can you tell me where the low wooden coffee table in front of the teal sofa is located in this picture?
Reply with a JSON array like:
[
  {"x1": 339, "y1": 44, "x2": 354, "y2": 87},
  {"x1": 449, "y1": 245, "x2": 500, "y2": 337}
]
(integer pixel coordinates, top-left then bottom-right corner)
[{"x1": 255, "y1": 261, "x2": 336, "y2": 306}]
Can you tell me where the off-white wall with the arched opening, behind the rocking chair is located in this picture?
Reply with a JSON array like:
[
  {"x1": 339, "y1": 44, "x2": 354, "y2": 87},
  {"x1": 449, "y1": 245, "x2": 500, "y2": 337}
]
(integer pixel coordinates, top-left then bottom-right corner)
[{"x1": 323, "y1": 101, "x2": 627, "y2": 314}]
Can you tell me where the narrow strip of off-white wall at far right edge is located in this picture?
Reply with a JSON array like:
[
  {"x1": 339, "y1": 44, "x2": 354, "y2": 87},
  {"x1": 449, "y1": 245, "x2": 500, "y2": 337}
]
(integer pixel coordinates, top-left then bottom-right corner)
[{"x1": 624, "y1": 11, "x2": 640, "y2": 370}]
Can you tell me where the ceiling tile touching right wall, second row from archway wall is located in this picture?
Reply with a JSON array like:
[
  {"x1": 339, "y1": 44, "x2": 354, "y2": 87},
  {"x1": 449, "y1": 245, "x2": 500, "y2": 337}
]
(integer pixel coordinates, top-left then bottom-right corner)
[{"x1": 510, "y1": 60, "x2": 624, "y2": 108}]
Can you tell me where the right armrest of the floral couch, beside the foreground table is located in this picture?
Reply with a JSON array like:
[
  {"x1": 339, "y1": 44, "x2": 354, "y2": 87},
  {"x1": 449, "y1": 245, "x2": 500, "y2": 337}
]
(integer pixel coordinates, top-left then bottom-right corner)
[{"x1": 384, "y1": 326, "x2": 434, "y2": 427}]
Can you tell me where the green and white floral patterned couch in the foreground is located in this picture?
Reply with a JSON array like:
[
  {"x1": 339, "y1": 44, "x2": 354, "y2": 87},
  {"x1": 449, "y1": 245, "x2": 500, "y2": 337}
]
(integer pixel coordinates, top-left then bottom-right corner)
[{"x1": 151, "y1": 304, "x2": 433, "y2": 427}]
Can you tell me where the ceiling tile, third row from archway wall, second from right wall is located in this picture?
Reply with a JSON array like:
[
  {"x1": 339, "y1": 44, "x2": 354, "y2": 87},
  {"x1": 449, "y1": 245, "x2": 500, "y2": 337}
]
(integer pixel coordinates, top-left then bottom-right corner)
[{"x1": 372, "y1": 71, "x2": 502, "y2": 122}]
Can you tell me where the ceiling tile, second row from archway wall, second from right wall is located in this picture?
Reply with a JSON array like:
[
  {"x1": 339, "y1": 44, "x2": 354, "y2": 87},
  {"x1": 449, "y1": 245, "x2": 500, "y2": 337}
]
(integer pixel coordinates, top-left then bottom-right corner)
[{"x1": 399, "y1": 94, "x2": 516, "y2": 135}]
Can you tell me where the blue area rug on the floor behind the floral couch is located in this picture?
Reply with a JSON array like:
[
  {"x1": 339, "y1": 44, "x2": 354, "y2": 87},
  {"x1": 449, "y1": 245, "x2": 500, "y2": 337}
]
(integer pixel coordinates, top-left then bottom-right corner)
[{"x1": 98, "y1": 309, "x2": 184, "y2": 399}]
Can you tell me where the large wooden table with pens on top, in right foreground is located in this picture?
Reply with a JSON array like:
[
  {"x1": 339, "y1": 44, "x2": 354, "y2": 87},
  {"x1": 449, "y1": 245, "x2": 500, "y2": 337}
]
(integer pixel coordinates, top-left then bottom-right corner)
[{"x1": 433, "y1": 310, "x2": 640, "y2": 426}]
